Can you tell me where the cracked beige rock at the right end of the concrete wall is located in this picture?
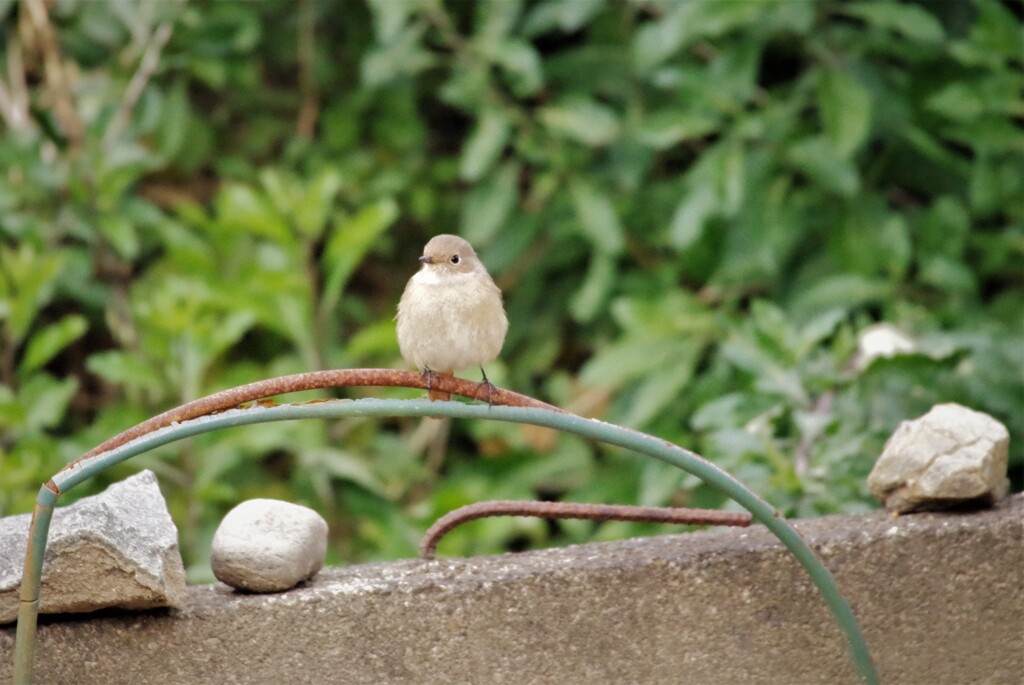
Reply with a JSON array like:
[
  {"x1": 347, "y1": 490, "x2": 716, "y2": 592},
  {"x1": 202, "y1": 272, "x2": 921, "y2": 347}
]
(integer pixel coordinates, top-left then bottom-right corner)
[{"x1": 867, "y1": 403, "x2": 1010, "y2": 513}]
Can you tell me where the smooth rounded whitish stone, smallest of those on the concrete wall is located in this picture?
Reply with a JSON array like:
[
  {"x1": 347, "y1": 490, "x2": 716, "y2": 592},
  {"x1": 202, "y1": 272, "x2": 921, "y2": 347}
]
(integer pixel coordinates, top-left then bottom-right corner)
[{"x1": 210, "y1": 500, "x2": 327, "y2": 592}]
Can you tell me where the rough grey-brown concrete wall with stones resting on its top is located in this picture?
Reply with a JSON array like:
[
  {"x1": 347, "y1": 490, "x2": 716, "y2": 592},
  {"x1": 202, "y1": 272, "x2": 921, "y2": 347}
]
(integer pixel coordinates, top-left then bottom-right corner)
[{"x1": 0, "y1": 495, "x2": 1024, "y2": 685}]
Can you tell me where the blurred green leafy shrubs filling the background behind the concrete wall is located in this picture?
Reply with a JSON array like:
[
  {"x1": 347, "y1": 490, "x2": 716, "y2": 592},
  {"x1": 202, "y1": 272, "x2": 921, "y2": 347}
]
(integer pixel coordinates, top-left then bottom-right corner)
[{"x1": 0, "y1": 0, "x2": 1024, "y2": 580}]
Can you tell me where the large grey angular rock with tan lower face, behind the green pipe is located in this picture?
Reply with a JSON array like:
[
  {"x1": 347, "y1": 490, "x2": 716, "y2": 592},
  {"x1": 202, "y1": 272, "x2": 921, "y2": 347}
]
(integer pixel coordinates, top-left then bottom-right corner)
[{"x1": 0, "y1": 471, "x2": 185, "y2": 624}]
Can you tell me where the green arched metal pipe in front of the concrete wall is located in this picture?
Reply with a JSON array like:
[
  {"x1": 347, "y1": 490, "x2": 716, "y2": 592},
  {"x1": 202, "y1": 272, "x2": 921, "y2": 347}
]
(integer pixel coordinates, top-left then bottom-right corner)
[{"x1": 14, "y1": 398, "x2": 879, "y2": 685}]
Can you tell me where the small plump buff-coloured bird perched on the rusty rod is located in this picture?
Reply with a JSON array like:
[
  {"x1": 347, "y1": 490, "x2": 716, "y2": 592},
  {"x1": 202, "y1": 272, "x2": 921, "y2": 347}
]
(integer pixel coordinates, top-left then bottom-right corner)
[{"x1": 396, "y1": 234, "x2": 509, "y2": 399}]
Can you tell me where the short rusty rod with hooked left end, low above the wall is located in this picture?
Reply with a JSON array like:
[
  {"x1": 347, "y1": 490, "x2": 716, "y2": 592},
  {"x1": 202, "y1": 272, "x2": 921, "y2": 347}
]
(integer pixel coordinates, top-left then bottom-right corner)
[{"x1": 420, "y1": 500, "x2": 753, "y2": 559}]
